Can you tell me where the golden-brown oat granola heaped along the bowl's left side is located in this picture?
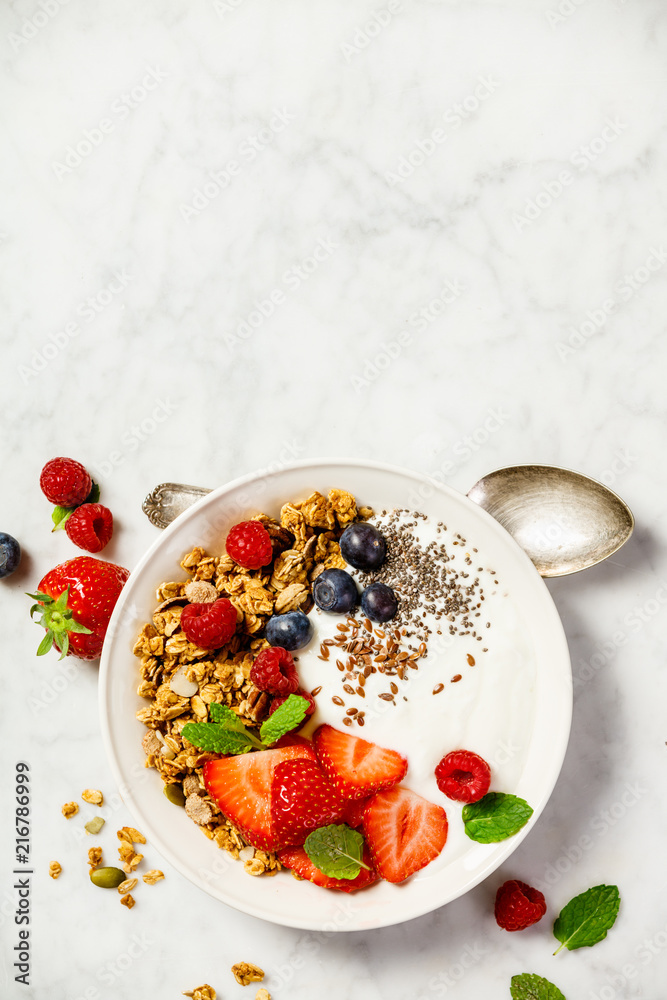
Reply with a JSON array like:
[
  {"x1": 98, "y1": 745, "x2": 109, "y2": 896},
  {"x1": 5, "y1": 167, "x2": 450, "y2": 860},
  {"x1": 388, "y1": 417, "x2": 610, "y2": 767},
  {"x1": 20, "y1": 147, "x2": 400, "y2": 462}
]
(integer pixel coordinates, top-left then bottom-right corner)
[{"x1": 134, "y1": 489, "x2": 372, "y2": 875}]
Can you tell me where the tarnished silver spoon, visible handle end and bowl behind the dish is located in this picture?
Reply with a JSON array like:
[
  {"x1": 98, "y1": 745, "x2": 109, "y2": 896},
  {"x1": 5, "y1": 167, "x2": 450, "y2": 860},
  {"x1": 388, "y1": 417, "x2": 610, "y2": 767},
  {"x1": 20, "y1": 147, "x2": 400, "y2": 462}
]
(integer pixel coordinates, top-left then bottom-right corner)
[{"x1": 142, "y1": 465, "x2": 635, "y2": 577}]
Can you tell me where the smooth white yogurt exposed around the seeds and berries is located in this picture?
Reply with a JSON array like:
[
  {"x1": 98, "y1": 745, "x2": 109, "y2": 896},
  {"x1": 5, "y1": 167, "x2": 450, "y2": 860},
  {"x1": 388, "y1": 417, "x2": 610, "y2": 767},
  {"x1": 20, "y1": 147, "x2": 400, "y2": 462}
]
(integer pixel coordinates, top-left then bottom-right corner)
[{"x1": 296, "y1": 515, "x2": 536, "y2": 878}]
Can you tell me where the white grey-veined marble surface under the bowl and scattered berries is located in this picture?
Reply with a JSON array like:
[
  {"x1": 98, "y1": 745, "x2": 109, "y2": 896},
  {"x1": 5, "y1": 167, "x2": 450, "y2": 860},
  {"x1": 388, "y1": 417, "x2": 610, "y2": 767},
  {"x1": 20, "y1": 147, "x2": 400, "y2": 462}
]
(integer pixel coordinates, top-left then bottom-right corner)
[{"x1": 0, "y1": 0, "x2": 667, "y2": 1000}]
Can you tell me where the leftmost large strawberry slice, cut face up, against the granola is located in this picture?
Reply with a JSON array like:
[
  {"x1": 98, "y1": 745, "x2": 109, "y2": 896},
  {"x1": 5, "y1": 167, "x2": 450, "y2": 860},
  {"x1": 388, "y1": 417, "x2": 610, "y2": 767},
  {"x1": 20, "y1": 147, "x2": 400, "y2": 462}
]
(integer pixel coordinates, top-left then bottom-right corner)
[{"x1": 204, "y1": 746, "x2": 317, "y2": 851}]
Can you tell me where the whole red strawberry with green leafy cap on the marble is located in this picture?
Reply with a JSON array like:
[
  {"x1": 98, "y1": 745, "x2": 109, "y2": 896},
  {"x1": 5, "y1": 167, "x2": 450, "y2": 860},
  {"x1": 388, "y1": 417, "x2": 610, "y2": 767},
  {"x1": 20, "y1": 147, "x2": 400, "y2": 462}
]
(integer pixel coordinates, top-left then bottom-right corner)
[{"x1": 28, "y1": 556, "x2": 130, "y2": 660}]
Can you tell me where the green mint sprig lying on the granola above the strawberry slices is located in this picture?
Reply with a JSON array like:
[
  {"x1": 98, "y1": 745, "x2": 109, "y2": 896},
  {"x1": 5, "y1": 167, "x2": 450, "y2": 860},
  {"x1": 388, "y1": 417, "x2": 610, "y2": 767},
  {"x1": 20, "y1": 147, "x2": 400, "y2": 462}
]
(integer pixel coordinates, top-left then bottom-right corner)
[{"x1": 182, "y1": 694, "x2": 308, "y2": 755}]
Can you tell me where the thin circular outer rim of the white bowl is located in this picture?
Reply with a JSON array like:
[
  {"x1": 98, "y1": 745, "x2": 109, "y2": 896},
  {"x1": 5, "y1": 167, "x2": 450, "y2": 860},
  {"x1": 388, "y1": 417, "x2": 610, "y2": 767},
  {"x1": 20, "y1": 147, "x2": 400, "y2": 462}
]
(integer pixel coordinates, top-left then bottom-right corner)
[{"x1": 99, "y1": 457, "x2": 573, "y2": 932}]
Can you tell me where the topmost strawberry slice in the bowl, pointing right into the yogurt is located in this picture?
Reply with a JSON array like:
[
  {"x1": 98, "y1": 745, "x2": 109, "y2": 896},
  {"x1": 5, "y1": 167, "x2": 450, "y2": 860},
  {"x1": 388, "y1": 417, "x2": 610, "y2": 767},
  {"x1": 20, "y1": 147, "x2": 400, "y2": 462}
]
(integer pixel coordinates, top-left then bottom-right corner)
[{"x1": 313, "y1": 725, "x2": 408, "y2": 799}]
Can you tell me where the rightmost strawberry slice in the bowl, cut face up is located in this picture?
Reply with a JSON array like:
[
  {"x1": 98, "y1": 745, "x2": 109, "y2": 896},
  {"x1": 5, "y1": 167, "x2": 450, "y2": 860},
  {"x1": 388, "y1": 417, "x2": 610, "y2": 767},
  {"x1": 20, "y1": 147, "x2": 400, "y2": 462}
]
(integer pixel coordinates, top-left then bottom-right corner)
[{"x1": 364, "y1": 788, "x2": 447, "y2": 882}]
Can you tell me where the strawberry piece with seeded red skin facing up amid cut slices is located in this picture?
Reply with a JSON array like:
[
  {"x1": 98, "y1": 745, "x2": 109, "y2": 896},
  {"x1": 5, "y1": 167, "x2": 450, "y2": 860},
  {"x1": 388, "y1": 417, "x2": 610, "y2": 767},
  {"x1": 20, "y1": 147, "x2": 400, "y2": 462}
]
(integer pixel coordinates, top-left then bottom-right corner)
[{"x1": 271, "y1": 759, "x2": 343, "y2": 847}]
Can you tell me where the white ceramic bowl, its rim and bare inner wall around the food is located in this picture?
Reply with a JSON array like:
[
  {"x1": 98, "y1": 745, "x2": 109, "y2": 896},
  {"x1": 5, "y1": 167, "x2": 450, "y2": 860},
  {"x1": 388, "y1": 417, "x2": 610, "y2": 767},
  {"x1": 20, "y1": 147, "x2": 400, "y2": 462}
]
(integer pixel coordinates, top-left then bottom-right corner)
[{"x1": 100, "y1": 460, "x2": 572, "y2": 930}]
